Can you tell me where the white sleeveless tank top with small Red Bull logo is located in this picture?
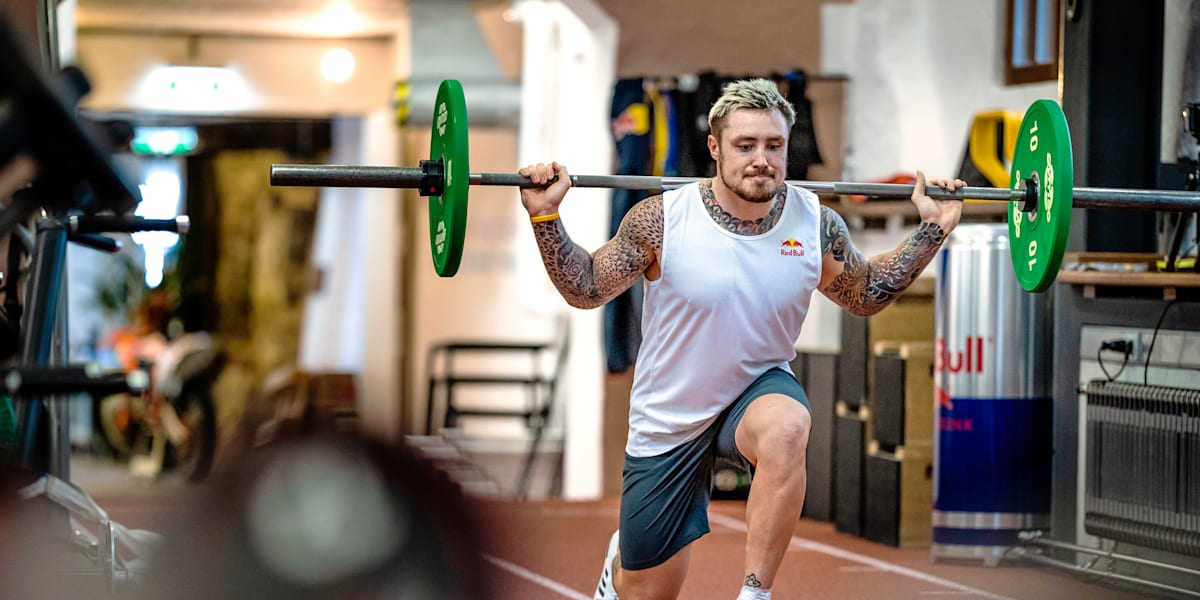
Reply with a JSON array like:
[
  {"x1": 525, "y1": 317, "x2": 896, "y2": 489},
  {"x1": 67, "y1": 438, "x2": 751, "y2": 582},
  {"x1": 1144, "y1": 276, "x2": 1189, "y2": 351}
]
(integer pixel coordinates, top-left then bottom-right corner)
[{"x1": 625, "y1": 184, "x2": 821, "y2": 456}]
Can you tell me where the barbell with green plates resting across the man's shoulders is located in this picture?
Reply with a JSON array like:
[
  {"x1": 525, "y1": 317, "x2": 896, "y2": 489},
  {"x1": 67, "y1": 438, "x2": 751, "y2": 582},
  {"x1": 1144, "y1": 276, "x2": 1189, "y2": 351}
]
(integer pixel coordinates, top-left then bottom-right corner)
[{"x1": 271, "y1": 79, "x2": 1200, "y2": 292}]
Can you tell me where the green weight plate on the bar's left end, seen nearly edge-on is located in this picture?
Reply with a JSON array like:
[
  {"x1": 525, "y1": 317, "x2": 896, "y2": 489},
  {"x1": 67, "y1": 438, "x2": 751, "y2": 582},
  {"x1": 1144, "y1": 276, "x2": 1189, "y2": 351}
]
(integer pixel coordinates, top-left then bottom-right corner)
[{"x1": 430, "y1": 79, "x2": 470, "y2": 277}]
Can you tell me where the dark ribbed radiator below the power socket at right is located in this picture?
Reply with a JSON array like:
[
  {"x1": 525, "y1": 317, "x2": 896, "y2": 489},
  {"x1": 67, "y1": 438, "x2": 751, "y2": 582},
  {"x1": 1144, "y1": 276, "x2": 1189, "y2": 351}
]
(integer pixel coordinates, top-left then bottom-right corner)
[{"x1": 1084, "y1": 380, "x2": 1200, "y2": 556}]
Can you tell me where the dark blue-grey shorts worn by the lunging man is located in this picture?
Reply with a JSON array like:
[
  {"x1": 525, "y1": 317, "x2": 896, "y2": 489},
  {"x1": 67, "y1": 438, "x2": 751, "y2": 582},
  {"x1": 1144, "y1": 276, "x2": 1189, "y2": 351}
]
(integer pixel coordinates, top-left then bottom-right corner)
[{"x1": 620, "y1": 368, "x2": 812, "y2": 570}]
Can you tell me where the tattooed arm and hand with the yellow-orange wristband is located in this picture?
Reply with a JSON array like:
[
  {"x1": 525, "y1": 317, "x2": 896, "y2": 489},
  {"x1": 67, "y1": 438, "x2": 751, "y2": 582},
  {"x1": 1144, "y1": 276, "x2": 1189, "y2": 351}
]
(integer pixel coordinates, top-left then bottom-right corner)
[{"x1": 521, "y1": 163, "x2": 662, "y2": 308}]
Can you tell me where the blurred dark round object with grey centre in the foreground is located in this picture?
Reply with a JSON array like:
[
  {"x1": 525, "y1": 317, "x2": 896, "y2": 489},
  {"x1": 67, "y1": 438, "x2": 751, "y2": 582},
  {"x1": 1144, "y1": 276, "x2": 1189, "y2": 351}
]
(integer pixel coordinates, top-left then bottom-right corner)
[{"x1": 137, "y1": 434, "x2": 490, "y2": 600}]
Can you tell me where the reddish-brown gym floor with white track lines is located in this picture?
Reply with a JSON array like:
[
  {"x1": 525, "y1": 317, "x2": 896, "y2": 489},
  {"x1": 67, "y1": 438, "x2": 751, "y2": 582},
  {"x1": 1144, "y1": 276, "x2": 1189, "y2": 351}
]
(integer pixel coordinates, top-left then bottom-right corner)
[{"x1": 72, "y1": 457, "x2": 1157, "y2": 600}]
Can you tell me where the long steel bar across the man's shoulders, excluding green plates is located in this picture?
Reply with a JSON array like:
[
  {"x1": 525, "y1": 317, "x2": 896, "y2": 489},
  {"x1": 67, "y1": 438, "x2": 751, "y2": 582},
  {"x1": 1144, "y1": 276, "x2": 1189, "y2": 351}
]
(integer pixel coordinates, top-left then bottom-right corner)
[{"x1": 271, "y1": 164, "x2": 1200, "y2": 212}]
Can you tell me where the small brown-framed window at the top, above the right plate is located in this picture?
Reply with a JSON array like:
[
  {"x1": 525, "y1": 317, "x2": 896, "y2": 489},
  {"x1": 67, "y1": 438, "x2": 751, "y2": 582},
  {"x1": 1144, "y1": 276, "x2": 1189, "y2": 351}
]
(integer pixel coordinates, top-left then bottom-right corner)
[{"x1": 1004, "y1": 0, "x2": 1061, "y2": 85}]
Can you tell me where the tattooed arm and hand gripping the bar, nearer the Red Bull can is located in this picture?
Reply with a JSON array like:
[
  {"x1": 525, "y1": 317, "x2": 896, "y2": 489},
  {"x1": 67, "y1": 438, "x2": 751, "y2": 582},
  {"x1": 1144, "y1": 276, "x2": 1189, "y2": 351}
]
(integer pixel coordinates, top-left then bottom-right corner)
[{"x1": 820, "y1": 172, "x2": 965, "y2": 317}]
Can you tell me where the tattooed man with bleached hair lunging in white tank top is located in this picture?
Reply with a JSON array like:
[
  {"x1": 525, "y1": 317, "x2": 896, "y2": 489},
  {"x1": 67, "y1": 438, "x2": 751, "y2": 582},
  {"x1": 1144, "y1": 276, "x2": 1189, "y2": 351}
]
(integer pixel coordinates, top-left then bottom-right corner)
[{"x1": 520, "y1": 79, "x2": 966, "y2": 600}]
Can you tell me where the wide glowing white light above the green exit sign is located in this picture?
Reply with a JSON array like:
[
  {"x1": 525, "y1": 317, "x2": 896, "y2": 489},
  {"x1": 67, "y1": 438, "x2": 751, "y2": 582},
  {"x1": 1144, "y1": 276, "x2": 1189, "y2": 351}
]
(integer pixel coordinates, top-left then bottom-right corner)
[{"x1": 140, "y1": 66, "x2": 248, "y2": 113}]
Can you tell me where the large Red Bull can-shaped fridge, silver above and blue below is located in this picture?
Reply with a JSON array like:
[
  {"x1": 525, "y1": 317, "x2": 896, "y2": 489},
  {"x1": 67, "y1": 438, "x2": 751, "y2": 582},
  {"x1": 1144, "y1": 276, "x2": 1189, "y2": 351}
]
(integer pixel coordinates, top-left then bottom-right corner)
[{"x1": 931, "y1": 224, "x2": 1052, "y2": 565}]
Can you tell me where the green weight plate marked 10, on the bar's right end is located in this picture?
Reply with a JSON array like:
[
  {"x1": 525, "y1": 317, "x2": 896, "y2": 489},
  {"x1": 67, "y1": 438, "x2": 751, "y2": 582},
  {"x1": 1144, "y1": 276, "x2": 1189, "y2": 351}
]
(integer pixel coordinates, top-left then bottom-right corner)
[{"x1": 1008, "y1": 100, "x2": 1075, "y2": 292}]
